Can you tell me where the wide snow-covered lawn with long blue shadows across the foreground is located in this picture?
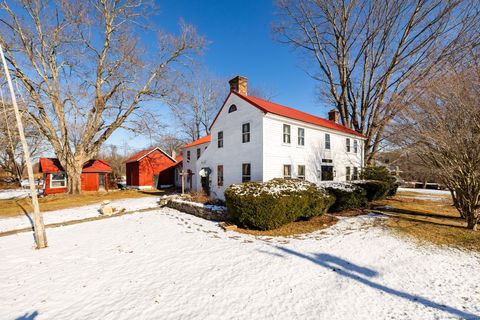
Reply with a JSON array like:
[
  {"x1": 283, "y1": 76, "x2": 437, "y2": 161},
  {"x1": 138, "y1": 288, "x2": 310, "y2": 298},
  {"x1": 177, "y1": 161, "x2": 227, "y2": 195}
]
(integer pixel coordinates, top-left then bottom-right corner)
[{"x1": 0, "y1": 208, "x2": 480, "y2": 320}]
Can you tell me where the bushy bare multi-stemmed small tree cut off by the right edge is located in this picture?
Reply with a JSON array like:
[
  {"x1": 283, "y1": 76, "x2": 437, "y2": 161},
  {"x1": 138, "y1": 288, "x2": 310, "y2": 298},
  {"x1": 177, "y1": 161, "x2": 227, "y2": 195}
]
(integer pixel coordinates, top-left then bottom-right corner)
[{"x1": 396, "y1": 68, "x2": 480, "y2": 229}]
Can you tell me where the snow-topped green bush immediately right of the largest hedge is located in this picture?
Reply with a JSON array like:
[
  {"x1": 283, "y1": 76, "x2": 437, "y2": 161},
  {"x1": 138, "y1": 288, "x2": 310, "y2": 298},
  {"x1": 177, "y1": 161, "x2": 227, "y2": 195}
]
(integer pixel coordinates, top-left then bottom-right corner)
[{"x1": 321, "y1": 182, "x2": 368, "y2": 212}]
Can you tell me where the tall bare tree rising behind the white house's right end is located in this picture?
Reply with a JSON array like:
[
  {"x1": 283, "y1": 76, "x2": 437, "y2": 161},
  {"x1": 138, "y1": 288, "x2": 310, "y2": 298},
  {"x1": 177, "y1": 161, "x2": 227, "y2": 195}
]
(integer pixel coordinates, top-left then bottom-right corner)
[{"x1": 274, "y1": 0, "x2": 480, "y2": 164}]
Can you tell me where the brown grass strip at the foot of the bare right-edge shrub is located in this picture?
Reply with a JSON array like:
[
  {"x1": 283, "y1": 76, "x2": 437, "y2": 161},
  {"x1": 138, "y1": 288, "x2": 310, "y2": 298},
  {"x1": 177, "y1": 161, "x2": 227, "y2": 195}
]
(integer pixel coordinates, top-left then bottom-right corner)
[{"x1": 384, "y1": 218, "x2": 480, "y2": 252}]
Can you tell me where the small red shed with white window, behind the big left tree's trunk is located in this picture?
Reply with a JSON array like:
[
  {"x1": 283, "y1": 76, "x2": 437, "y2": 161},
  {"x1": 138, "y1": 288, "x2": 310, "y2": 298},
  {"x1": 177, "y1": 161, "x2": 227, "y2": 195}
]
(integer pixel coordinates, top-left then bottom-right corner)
[{"x1": 39, "y1": 158, "x2": 112, "y2": 195}]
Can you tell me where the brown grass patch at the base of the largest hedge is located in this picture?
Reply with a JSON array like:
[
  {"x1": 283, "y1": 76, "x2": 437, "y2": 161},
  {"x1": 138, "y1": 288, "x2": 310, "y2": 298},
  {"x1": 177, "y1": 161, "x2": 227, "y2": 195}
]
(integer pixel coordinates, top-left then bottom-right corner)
[{"x1": 236, "y1": 214, "x2": 338, "y2": 237}]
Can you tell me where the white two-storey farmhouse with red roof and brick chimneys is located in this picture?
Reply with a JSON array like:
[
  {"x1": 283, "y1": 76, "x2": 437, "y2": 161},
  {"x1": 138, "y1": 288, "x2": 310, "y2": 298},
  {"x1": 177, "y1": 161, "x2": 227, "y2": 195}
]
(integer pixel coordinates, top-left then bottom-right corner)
[{"x1": 182, "y1": 76, "x2": 365, "y2": 199}]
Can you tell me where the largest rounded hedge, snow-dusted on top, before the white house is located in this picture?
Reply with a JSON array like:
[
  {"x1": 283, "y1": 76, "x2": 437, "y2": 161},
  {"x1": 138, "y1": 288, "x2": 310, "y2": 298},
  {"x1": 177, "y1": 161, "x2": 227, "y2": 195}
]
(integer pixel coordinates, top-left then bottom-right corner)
[{"x1": 225, "y1": 179, "x2": 335, "y2": 230}]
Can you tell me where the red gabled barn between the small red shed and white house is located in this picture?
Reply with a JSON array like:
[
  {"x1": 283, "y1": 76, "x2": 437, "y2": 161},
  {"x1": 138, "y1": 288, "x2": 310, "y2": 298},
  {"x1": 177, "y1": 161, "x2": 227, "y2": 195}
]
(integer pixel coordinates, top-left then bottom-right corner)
[{"x1": 125, "y1": 148, "x2": 181, "y2": 189}]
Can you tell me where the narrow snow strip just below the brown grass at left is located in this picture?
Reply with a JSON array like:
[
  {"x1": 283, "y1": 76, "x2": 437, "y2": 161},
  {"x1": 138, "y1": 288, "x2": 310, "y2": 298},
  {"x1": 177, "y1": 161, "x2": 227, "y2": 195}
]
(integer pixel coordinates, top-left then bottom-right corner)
[{"x1": 0, "y1": 197, "x2": 159, "y2": 232}]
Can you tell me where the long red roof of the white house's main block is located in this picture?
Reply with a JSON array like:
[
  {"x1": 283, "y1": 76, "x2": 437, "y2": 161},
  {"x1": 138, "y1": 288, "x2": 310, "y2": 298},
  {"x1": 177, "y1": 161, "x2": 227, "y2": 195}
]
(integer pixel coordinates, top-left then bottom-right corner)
[{"x1": 210, "y1": 91, "x2": 365, "y2": 138}]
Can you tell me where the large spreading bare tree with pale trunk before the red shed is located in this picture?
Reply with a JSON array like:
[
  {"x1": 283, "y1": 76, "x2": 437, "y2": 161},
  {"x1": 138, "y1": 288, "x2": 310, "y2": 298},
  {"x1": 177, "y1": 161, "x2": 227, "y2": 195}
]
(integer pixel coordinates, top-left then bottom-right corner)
[{"x1": 0, "y1": 0, "x2": 204, "y2": 193}]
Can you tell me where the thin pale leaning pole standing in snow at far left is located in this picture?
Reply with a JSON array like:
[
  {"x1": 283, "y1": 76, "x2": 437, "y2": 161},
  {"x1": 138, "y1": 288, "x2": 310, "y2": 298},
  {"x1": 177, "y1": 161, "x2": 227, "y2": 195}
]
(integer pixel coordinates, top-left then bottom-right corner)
[{"x1": 0, "y1": 45, "x2": 47, "y2": 249}]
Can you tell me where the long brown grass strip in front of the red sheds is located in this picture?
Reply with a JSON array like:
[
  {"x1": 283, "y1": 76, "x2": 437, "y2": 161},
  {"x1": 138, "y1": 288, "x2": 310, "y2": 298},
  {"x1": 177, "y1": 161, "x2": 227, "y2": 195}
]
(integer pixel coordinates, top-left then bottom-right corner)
[{"x1": 0, "y1": 190, "x2": 159, "y2": 217}]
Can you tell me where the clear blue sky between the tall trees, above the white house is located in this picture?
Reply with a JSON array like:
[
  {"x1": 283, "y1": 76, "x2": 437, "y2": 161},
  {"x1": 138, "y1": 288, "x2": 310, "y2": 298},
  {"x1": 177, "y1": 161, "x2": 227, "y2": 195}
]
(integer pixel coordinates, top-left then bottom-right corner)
[{"x1": 107, "y1": 0, "x2": 328, "y2": 149}]
